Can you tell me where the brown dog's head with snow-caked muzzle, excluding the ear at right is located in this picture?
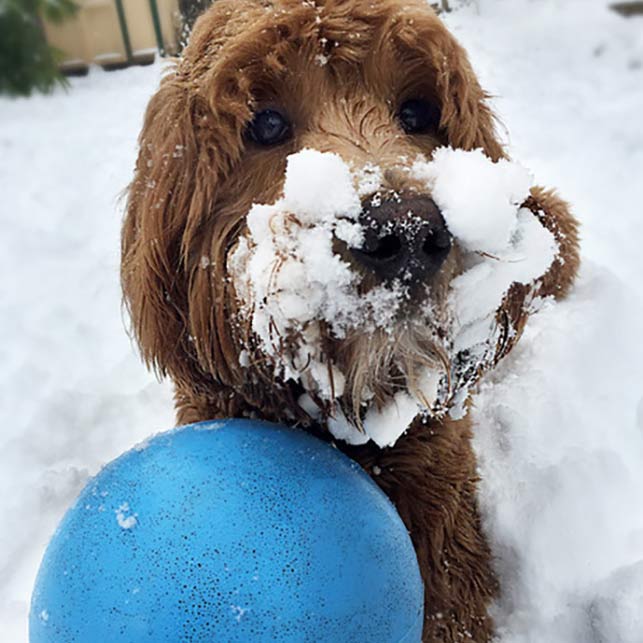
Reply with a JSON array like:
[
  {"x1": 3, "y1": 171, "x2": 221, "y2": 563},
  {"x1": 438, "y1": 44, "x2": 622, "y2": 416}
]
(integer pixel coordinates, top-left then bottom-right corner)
[{"x1": 122, "y1": 0, "x2": 573, "y2": 444}]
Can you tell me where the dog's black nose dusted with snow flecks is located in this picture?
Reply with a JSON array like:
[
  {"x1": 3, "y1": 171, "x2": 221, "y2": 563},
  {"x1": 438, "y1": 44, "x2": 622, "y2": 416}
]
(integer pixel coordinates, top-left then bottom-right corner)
[{"x1": 351, "y1": 196, "x2": 451, "y2": 283}]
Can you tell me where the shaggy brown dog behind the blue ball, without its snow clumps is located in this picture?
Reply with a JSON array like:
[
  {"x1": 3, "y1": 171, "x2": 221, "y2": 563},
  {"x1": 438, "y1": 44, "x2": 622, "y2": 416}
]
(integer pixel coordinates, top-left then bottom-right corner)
[{"x1": 121, "y1": 0, "x2": 579, "y2": 643}]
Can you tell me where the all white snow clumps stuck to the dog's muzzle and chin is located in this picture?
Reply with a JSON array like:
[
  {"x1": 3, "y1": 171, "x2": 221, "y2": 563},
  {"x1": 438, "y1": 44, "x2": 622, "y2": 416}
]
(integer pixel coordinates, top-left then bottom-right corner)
[{"x1": 229, "y1": 148, "x2": 557, "y2": 446}]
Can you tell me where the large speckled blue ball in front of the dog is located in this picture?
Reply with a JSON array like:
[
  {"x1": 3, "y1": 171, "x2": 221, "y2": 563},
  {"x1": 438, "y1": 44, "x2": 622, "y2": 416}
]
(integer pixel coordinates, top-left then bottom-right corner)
[{"x1": 30, "y1": 420, "x2": 424, "y2": 643}]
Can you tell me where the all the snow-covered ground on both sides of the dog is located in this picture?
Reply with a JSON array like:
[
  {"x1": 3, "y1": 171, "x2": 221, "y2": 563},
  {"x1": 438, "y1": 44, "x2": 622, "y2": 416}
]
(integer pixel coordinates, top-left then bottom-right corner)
[{"x1": 0, "y1": 0, "x2": 643, "y2": 643}]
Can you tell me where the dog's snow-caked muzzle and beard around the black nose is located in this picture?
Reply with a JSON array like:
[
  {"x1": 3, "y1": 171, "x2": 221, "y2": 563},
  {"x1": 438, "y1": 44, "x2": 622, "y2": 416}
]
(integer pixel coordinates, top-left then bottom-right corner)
[{"x1": 228, "y1": 148, "x2": 557, "y2": 446}]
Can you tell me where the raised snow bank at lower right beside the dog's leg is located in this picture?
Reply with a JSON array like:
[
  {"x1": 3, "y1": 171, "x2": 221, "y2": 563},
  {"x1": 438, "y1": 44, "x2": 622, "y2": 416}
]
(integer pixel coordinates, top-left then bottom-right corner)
[{"x1": 472, "y1": 265, "x2": 643, "y2": 643}]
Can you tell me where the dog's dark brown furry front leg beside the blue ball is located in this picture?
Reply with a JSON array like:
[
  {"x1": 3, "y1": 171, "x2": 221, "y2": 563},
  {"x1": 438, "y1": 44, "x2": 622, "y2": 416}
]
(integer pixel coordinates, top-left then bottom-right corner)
[{"x1": 338, "y1": 418, "x2": 497, "y2": 643}]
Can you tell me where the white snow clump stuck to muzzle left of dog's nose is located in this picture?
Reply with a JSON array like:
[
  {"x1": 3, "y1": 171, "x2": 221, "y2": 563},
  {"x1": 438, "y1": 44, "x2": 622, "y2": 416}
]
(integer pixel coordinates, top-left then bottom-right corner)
[{"x1": 229, "y1": 150, "x2": 400, "y2": 400}]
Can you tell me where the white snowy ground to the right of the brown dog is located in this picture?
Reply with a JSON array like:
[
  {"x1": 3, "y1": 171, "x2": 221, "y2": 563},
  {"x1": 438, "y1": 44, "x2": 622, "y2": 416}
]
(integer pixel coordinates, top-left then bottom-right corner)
[{"x1": 449, "y1": 0, "x2": 643, "y2": 643}]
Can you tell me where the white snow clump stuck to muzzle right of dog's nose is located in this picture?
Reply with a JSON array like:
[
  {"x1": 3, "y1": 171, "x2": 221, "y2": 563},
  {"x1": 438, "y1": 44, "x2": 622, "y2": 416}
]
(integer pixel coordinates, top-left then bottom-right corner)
[{"x1": 411, "y1": 148, "x2": 559, "y2": 419}]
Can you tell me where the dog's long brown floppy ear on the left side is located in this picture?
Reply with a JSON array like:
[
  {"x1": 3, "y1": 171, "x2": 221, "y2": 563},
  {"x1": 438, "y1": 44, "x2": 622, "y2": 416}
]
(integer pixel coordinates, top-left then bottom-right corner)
[{"x1": 121, "y1": 0, "x2": 282, "y2": 400}]
